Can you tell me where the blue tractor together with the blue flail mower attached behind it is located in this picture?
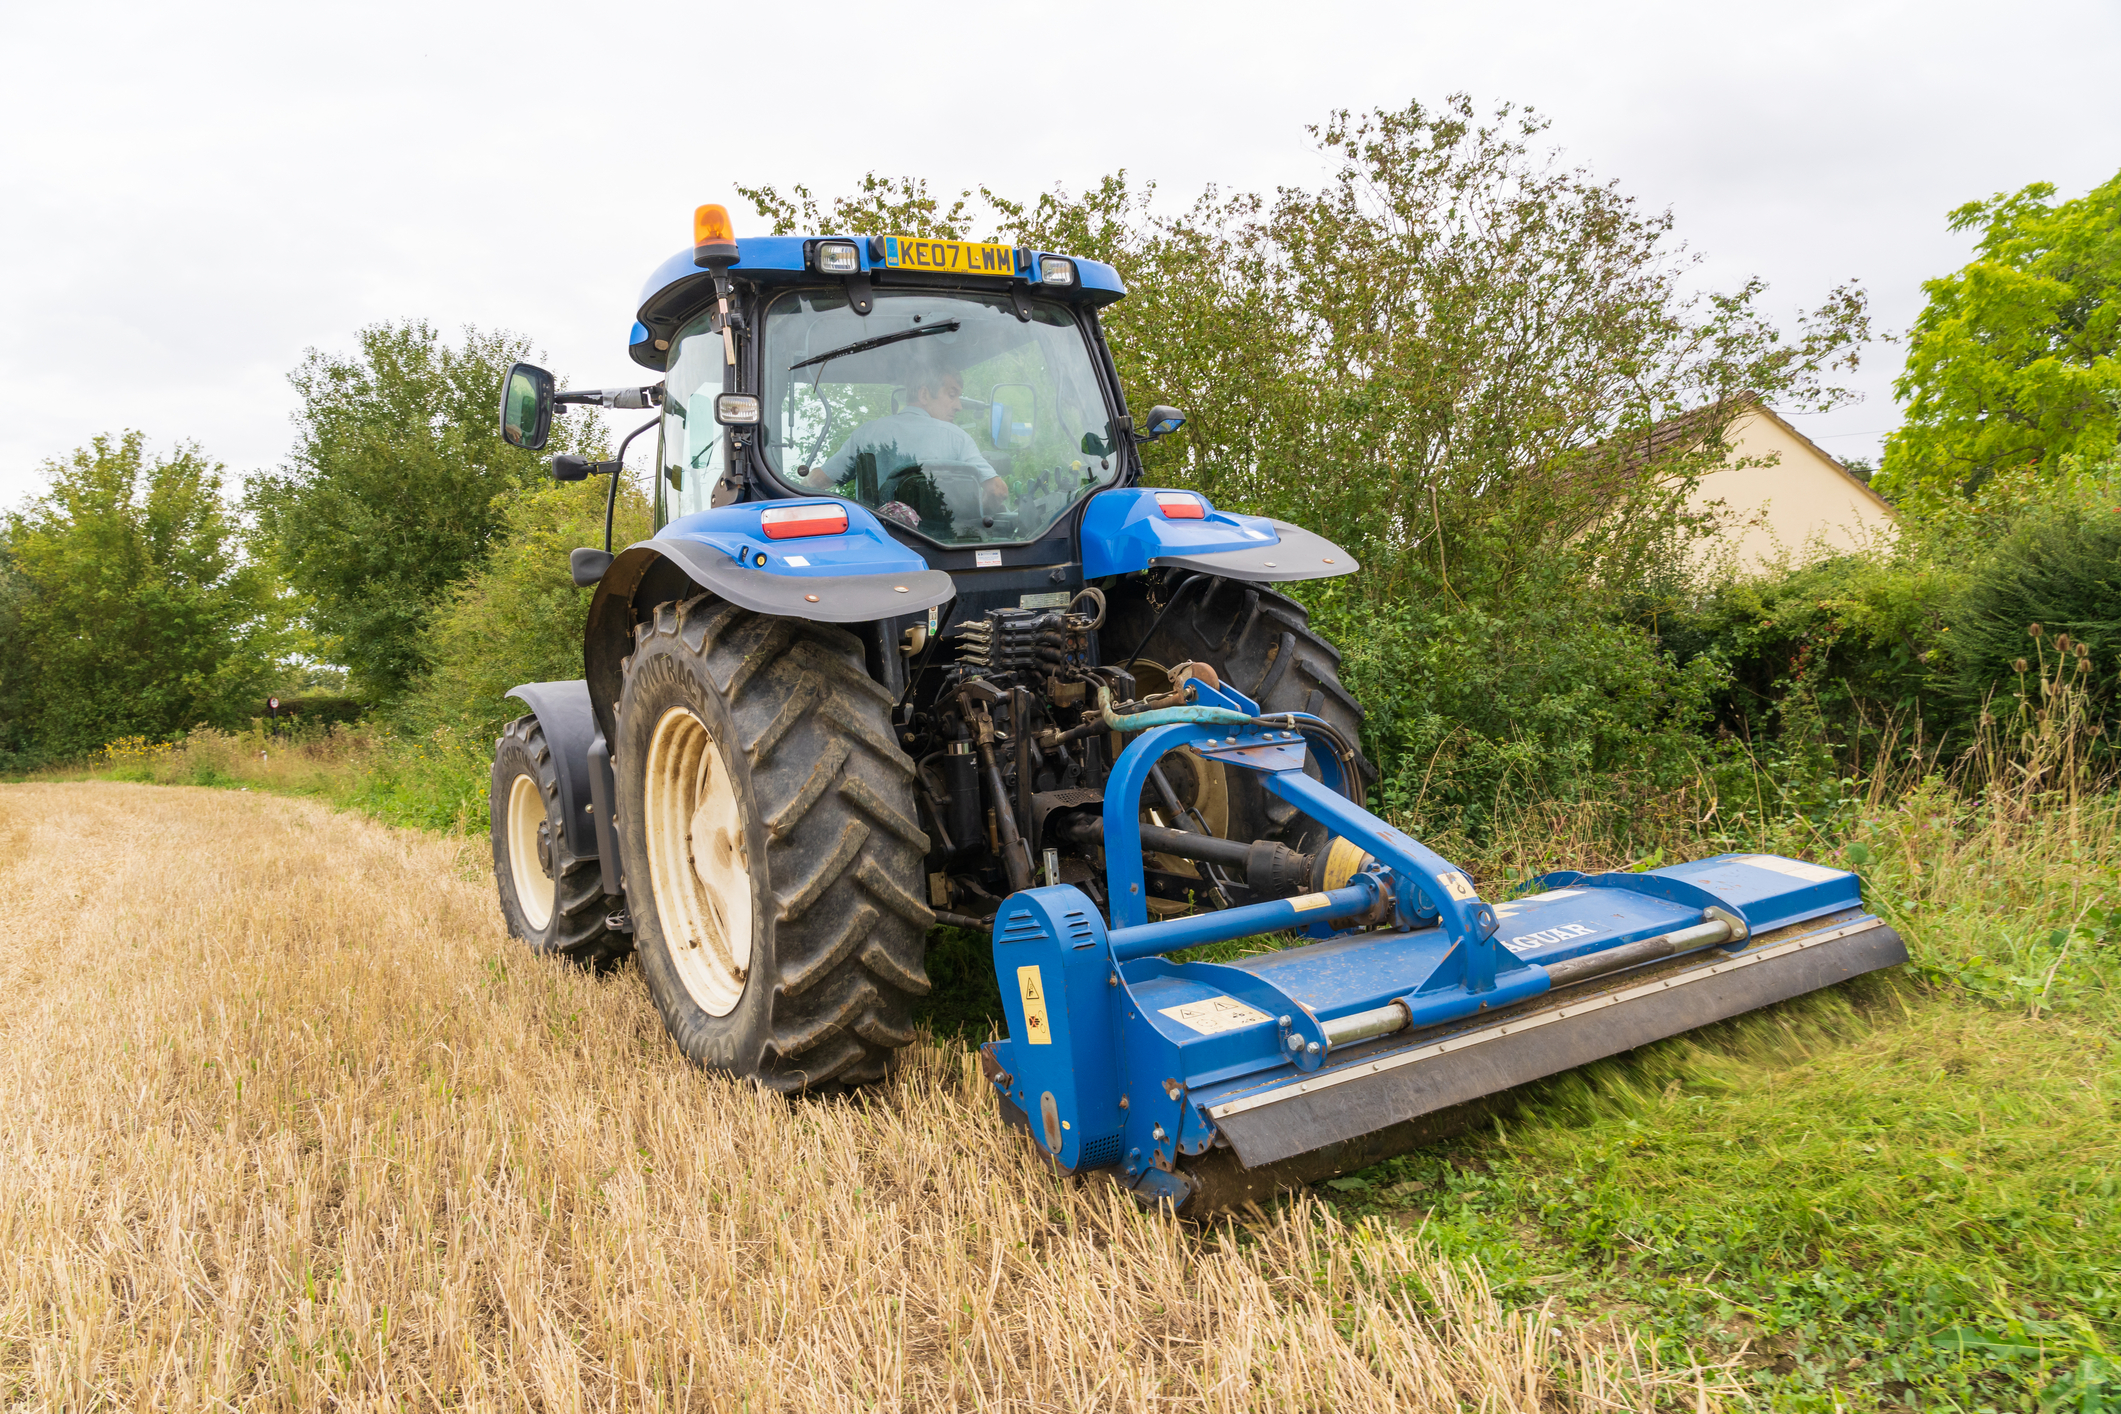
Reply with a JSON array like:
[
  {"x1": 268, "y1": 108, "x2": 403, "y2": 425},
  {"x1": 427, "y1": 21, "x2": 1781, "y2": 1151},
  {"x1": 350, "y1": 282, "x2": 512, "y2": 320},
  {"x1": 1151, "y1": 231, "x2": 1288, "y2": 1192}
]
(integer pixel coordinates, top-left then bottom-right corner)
[{"x1": 492, "y1": 206, "x2": 1905, "y2": 1213}]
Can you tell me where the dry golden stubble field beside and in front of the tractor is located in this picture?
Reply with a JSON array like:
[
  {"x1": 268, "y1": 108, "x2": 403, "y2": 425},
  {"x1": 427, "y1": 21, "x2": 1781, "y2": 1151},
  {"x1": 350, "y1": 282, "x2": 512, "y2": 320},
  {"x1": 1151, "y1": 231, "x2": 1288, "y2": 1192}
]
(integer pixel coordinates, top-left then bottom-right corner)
[{"x1": 0, "y1": 782, "x2": 1720, "y2": 1410}]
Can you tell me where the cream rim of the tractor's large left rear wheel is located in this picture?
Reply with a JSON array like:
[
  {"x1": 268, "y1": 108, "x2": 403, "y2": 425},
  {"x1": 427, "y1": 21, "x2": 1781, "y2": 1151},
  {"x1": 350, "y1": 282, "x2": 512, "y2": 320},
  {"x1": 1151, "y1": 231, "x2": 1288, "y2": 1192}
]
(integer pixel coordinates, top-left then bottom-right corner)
[{"x1": 643, "y1": 708, "x2": 751, "y2": 1015}]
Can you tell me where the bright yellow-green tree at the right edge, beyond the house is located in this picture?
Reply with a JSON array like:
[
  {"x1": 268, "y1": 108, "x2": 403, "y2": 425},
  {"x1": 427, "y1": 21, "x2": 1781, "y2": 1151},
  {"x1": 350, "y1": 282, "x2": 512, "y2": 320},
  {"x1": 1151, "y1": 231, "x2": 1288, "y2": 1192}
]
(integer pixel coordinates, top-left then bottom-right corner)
[{"x1": 1879, "y1": 176, "x2": 2121, "y2": 505}]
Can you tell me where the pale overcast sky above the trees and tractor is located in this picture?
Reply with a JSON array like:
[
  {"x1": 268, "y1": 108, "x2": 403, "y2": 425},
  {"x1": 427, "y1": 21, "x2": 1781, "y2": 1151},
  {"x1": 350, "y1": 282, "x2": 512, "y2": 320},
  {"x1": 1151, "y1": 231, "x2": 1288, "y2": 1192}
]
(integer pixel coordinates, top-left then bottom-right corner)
[{"x1": 0, "y1": 0, "x2": 2121, "y2": 505}]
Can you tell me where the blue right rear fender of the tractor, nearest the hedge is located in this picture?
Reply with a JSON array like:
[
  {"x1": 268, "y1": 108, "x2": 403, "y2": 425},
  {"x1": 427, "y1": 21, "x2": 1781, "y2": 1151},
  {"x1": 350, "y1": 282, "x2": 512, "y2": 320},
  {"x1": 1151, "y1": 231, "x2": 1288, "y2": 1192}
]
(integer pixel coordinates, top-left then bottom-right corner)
[{"x1": 1082, "y1": 485, "x2": 1357, "y2": 581}]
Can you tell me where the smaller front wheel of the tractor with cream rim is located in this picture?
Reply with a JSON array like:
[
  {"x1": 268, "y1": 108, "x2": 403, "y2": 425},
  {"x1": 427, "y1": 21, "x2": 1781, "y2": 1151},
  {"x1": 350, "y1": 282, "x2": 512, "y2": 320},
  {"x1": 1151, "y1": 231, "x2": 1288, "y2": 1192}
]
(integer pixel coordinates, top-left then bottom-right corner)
[{"x1": 488, "y1": 717, "x2": 632, "y2": 967}]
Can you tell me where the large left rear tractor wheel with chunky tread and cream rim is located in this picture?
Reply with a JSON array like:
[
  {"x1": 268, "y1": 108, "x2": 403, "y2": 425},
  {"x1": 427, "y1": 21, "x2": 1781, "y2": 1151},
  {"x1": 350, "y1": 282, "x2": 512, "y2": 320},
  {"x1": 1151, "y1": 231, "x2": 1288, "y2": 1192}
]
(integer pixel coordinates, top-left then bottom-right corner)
[{"x1": 613, "y1": 596, "x2": 935, "y2": 1092}]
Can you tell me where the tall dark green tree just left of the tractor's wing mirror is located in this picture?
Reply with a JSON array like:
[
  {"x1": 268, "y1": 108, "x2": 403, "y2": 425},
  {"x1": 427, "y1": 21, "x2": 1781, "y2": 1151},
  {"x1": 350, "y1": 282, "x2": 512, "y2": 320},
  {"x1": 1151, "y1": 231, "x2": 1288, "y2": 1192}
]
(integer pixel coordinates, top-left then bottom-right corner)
[{"x1": 248, "y1": 320, "x2": 596, "y2": 702}]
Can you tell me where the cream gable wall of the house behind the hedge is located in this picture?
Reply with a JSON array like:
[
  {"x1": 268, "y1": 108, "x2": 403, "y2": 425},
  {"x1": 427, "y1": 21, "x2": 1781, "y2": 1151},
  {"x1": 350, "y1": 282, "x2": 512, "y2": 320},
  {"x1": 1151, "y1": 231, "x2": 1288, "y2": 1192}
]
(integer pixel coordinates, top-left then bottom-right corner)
[{"x1": 1688, "y1": 413, "x2": 1892, "y2": 570}]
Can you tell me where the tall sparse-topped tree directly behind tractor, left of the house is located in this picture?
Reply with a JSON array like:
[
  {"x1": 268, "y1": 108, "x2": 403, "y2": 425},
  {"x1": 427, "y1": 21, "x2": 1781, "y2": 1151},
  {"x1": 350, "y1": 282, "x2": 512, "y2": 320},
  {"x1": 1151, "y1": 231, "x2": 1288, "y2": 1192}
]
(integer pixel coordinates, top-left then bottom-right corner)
[{"x1": 747, "y1": 98, "x2": 1866, "y2": 831}]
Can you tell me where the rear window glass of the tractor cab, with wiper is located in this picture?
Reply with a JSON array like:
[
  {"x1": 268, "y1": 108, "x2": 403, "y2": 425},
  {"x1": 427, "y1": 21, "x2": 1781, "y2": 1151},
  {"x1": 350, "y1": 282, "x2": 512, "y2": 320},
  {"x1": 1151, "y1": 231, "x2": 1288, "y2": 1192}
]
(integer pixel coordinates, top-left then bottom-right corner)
[{"x1": 761, "y1": 290, "x2": 1120, "y2": 545}]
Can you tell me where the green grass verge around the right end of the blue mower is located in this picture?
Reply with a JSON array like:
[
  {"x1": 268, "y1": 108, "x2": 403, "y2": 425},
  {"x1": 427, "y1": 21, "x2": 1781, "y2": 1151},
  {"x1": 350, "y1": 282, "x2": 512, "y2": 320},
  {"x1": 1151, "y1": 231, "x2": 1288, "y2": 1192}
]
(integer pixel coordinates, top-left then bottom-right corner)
[{"x1": 1321, "y1": 753, "x2": 2121, "y2": 1410}]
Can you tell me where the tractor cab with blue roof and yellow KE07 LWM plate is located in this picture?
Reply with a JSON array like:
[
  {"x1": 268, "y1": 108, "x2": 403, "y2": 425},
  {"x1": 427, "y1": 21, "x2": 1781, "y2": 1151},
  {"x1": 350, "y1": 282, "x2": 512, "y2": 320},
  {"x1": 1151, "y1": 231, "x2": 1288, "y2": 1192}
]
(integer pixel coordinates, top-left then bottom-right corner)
[{"x1": 632, "y1": 223, "x2": 1175, "y2": 564}]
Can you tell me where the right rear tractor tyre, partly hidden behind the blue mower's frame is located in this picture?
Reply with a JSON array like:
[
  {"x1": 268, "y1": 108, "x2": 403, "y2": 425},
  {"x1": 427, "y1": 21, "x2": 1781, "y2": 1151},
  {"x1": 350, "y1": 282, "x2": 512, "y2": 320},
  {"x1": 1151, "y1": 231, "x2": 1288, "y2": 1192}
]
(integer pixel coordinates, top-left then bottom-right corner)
[{"x1": 1103, "y1": 577, "x2": 1377, "y2": 852}]
